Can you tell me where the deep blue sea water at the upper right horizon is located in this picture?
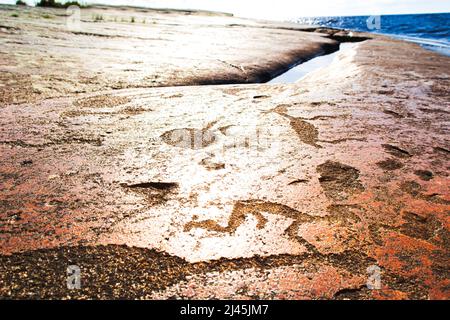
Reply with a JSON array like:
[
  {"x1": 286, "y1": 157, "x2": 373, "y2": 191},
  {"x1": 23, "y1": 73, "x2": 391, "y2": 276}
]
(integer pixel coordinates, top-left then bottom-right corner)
[{"x1": 295, "y1": 13, "x2": 450, "y2": 56}]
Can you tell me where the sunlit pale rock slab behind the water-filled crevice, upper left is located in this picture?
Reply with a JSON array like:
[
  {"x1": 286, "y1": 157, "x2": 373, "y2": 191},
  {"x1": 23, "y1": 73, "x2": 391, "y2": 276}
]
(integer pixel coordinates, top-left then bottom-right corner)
[{"x1": 0, "y1": 6, "x2": 339, "y2": 103}]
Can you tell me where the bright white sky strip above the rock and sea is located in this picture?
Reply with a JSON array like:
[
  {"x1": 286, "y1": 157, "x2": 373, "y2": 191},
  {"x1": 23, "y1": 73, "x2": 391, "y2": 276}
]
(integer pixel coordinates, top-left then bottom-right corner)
[{"x1": 0, "y1": 0, "x2": 450, "y2": 19}]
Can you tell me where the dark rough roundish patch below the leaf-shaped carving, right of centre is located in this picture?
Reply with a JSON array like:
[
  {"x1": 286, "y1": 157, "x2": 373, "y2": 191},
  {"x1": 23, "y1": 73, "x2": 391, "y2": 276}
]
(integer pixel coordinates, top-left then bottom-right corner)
[{"x1": 317, "y1": 161, "x2": 364, "y2": 200}]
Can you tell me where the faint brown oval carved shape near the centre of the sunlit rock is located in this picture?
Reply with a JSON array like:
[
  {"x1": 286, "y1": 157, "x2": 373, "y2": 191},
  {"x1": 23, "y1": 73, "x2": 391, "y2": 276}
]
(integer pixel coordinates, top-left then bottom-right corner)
[{"x1": 161, "y1": 128, "x2": 216, "y2": 150}]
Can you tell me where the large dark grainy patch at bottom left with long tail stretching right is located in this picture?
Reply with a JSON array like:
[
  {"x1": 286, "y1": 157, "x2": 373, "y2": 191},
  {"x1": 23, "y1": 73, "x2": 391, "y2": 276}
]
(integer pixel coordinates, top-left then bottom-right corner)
[{"x1": 0, "y1": 245, "x2": 374, "y2": 299}]
